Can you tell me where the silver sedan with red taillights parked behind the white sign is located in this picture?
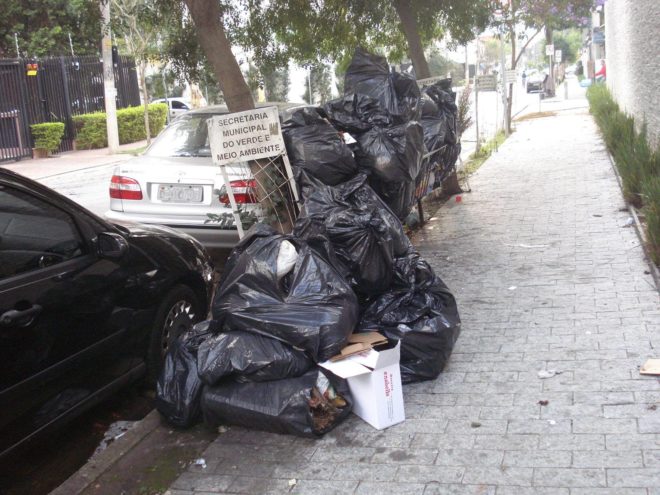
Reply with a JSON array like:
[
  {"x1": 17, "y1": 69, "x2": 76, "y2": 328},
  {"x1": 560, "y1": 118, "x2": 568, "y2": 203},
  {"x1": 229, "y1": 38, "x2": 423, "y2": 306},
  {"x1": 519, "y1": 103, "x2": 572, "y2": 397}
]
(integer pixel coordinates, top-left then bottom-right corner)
[{"x1": 105, "y1": 103, "x2": 300, "y2": 249}]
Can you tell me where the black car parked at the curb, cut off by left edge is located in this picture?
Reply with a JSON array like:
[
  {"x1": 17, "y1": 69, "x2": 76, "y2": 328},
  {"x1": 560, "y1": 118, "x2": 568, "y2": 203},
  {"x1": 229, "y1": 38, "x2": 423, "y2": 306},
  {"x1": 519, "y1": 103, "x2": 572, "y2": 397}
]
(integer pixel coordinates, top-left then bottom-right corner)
[{"x1": 0, "y1": 169, "x2": 213, "y2": 458}]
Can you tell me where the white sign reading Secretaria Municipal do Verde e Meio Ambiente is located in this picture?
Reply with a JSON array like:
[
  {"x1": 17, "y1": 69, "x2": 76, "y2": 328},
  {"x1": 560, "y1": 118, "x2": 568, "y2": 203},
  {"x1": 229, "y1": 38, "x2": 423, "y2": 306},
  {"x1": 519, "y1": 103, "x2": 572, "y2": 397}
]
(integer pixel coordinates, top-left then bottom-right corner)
[{"x1": 208, "y1": 107, "x2": 285, "y2": 165}]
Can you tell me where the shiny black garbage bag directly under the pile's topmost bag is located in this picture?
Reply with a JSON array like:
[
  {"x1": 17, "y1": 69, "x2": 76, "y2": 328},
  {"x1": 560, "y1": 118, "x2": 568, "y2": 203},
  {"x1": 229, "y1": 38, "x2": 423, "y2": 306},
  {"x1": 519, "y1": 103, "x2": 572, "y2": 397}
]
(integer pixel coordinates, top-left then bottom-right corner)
[{"x1": 355, "y1": 122, "x2": 425, "y2": 182}]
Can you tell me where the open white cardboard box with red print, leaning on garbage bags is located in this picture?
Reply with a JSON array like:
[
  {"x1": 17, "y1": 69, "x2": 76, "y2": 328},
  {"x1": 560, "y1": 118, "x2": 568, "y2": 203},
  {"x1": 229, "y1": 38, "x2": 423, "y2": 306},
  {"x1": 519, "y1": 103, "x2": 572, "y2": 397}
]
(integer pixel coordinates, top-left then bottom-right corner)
[{"x1": 320, "y1": 336, "x2": 406, "y2": 430}]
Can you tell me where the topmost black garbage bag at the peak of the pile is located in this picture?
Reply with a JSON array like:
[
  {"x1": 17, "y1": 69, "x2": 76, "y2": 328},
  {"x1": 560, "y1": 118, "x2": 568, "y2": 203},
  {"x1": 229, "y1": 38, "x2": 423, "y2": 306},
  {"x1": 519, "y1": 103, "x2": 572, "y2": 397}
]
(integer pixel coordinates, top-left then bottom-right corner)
[{"x1": 344, "y1": 48, "x2": 421, "y2": 125}]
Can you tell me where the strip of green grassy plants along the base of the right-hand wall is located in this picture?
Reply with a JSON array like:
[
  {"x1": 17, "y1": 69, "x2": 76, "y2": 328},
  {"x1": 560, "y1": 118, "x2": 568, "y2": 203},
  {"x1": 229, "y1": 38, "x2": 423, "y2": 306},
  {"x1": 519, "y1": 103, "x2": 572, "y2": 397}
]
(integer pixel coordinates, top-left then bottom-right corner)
[{"x1": 587, "y1": 84, "x2": 660, "y2": 264}]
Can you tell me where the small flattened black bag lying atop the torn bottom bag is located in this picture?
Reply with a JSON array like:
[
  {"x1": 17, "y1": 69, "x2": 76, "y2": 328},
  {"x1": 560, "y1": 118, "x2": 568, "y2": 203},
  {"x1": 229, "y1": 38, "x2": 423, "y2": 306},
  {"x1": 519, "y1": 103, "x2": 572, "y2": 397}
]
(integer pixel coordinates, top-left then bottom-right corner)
[{"x1": 197, "y1": 331, "x2": 314, "y2": 385}]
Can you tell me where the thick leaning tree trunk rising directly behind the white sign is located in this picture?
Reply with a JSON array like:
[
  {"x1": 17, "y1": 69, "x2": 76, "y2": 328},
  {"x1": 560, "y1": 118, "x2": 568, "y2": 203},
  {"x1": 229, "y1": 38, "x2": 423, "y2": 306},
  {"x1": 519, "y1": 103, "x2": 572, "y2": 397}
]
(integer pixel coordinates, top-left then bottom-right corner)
[{"x1": 184, "y1": 0, "x2": 254, "y2": 112}]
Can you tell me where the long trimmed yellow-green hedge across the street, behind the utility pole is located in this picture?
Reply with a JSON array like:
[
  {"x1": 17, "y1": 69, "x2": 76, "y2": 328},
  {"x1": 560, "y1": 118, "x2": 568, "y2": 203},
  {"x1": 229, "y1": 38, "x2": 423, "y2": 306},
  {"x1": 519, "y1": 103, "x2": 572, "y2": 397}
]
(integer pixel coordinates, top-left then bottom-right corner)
[{"x1": 73, "y1": 103, "x2": 167, "y2": 149}]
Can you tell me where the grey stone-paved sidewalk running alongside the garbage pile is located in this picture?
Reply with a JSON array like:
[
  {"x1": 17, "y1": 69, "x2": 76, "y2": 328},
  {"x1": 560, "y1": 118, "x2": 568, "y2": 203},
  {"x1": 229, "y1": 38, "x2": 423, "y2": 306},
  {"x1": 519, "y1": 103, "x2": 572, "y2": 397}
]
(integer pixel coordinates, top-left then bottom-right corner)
[{"x1": 170, "y1": 102, "x2": 660, "y2": 495}]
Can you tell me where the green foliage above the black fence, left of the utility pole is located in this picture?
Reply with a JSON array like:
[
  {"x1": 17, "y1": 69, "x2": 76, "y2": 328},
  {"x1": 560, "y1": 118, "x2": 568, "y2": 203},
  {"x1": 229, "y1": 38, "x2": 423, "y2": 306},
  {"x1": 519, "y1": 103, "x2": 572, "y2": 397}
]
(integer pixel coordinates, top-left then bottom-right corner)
[{"x1": 0, "y1": 0, "x2": 101, "y2": 58}]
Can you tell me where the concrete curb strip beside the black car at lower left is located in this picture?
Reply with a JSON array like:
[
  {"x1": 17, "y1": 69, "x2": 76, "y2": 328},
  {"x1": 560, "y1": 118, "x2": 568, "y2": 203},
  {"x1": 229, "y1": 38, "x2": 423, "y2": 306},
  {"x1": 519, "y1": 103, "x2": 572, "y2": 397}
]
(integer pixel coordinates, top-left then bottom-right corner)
[{"x1": 50, "y1": 409, "x2": 161, "y2": 495}]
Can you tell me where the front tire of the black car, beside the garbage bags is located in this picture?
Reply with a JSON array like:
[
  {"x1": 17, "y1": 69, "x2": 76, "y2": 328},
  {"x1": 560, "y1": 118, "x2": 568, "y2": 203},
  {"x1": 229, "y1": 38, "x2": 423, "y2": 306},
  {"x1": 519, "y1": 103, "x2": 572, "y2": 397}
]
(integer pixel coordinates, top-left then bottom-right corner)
[{"x1": 147, "y1": 285, "x2": 204, "y2": 385}]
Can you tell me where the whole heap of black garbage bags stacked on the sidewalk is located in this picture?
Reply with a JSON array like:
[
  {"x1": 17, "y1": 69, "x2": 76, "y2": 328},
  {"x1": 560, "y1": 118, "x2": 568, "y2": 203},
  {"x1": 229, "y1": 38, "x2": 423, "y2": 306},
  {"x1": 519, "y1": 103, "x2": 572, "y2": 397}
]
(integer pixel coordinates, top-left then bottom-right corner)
[{"x1": 156, "y1": 50, "x2": 461, "y2": 436}]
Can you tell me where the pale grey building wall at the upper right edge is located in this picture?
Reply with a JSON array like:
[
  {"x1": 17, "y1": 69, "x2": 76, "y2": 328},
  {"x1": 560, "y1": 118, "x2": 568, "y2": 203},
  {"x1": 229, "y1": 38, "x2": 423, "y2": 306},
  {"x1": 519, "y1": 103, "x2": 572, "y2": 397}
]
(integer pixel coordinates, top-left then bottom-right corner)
[{"x1": 605, "y1": 0, "x2": 660, "y2": 146}]
